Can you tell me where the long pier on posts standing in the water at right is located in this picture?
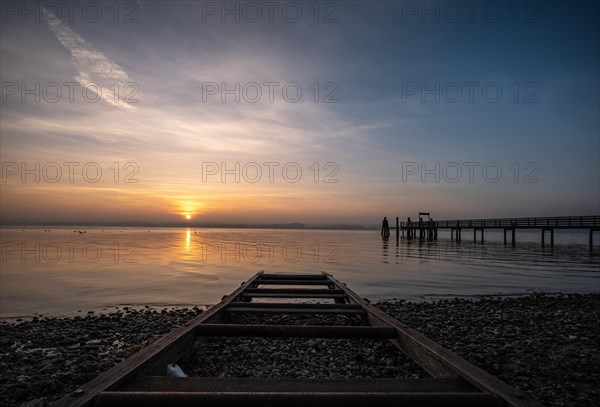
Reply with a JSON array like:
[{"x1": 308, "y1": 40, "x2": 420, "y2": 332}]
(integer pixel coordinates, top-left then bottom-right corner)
[{"x1": 382, "y1": 212, "x2": 600, "y2": 248}]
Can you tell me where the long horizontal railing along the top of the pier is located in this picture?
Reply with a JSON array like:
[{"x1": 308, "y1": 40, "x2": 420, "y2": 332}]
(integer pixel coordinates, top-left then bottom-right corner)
[{"x1": 400, "y1": 216, "x2": 600, "y2": 229}]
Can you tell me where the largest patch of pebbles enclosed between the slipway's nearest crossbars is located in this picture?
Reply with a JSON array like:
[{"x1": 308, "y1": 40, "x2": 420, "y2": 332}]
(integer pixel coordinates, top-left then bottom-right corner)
[{"x1": 183, "y1": 337, "x2": 427, "y2": 379}]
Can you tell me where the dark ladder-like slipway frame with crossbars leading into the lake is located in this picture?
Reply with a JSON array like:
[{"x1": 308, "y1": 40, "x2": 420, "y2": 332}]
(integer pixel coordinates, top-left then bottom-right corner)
[{"x1": 56, "y1": 272, "x2": 538, "y2": 407}]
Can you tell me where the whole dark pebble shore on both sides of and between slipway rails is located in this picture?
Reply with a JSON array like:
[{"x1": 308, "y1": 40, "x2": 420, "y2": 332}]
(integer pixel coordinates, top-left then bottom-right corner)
[{"x1": 0, "y1": 293, "x2": 600, "y2": 407}]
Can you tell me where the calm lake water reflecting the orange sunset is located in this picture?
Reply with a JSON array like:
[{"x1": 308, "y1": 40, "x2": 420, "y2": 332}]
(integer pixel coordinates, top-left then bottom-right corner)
[{"x1": 0, "y1": 227, "x2": 600, "y2": 318}]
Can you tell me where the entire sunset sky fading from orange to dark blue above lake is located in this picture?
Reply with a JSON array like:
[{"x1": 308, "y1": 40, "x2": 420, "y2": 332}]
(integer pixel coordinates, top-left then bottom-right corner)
[{"x1": 0, "y1": 0, "x2": 600, "y2": 225}]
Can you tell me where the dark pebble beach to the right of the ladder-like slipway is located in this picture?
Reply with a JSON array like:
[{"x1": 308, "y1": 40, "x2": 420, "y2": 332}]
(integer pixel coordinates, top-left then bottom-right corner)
[{"x1": 376, "y1": 294, "x2": 600, "y2": 406}]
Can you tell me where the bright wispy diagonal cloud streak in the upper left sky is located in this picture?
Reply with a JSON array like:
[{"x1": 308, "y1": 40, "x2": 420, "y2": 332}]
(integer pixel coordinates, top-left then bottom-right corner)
[{"x1": 44, "y1": 9, "x2": 135, "y2": 110}]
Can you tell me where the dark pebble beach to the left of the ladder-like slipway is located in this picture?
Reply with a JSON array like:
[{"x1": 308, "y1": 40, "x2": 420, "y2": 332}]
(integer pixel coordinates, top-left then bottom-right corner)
[{"x1": 0, "y1": 307, "x2": 201, "y2": 406}]
